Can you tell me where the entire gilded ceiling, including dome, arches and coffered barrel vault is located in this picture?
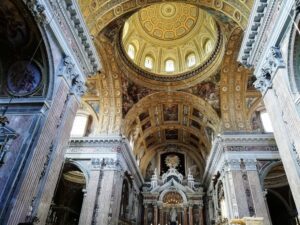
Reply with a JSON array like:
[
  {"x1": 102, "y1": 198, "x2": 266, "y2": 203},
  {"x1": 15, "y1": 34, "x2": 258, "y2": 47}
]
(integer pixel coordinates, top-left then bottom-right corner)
[{"x1": 79, "y1": 1, "x2": 264, "y2": 177}]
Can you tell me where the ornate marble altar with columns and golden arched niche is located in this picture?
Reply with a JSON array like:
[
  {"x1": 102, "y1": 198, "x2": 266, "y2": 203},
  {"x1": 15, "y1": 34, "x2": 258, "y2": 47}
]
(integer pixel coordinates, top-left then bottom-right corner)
[{"x1": 142, "y1": 167, "x2": 204, "y2": 225}]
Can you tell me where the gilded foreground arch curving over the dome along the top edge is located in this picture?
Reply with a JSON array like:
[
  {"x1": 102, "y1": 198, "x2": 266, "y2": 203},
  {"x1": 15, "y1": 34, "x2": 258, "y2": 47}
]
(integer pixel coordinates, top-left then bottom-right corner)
[{"x1": 79, "y1": 0, "x2": 253, "y2": 36}]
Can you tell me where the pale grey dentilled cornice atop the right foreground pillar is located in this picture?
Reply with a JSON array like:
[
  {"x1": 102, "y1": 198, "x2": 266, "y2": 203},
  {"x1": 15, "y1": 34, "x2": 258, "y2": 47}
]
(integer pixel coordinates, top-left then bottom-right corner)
[{"x1": 238, "y1": 0, "x2": 295, "y2": 72}]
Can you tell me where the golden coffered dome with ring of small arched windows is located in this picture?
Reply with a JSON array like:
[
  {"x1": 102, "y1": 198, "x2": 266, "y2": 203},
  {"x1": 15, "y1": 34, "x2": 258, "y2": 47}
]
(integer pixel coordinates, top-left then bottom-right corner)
[{"x1": 120, "y1": 2, "x2": 223, "y2": 89}]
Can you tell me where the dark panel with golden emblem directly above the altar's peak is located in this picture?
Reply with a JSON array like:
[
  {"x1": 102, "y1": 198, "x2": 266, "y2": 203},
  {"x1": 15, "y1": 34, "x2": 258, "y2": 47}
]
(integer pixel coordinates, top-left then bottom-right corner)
[{"x1": 160, "y1": 152, "x2": 185, "y2": 176}]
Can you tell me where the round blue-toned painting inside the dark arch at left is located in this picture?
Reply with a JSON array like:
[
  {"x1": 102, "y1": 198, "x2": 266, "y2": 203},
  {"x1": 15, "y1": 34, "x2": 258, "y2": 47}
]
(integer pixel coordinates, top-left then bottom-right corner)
[{"x1": 7, "y1": 61, "x2": 42, "y2": 96}]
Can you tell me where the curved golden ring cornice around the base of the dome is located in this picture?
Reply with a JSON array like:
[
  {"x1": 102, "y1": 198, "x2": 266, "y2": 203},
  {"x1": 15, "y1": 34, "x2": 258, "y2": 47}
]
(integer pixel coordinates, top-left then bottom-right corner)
[{"x1": 115, "y1": 24, "x2": 225, "y2": 90}]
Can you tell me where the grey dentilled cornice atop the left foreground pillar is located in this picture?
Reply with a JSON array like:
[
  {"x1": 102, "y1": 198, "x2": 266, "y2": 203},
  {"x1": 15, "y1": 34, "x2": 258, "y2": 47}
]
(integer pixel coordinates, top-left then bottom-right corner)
[{"x1": 46, "y1": 0, "x2": 101, "y2": 79}]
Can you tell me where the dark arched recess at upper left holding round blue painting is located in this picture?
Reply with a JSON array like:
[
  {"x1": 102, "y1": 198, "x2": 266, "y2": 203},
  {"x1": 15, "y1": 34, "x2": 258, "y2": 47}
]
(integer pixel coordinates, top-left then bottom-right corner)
[{"x1": 0, "y1": 0, "x2": 55, "y2": 99}]
